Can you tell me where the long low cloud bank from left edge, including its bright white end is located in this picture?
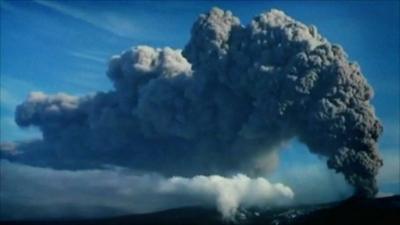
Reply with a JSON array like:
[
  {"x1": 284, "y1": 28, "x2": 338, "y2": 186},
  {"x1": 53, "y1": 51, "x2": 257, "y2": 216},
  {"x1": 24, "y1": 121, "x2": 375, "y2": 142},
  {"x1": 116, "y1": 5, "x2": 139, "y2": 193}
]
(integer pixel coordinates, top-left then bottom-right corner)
[{"x1": 0, "y1": 160, "x2": 293, "y2": 220}]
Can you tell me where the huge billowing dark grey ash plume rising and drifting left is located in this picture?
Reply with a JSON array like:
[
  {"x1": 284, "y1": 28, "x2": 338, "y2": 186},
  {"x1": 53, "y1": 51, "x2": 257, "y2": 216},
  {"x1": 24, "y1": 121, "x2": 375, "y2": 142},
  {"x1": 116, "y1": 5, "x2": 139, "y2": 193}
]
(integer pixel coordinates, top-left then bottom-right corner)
[{"x1": 5, "y1": 8, "x2": 382, "y2": 197}]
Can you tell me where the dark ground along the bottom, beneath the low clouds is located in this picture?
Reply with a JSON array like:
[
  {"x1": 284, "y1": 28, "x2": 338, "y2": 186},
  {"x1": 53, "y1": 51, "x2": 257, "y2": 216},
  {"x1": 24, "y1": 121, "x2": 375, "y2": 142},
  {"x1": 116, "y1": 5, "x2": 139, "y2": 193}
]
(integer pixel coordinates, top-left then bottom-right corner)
[{"x1": 0, "y1": 196, "x2": 400, "y2": 225}]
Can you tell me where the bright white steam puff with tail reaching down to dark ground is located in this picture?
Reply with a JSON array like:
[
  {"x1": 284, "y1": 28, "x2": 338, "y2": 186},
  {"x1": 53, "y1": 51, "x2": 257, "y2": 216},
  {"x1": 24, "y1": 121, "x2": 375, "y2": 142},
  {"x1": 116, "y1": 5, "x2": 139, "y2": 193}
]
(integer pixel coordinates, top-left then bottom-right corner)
[{"x1": 160, "y1": 174, "x2": 294, "y2": 219}]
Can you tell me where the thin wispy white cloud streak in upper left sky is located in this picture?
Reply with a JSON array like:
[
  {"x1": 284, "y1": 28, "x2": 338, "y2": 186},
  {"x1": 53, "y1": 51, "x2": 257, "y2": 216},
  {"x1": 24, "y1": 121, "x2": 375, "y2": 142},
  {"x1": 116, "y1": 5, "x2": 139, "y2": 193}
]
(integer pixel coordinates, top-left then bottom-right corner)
[{"x1": 35, "y1": 0, "x2": 139, "y2": 38}]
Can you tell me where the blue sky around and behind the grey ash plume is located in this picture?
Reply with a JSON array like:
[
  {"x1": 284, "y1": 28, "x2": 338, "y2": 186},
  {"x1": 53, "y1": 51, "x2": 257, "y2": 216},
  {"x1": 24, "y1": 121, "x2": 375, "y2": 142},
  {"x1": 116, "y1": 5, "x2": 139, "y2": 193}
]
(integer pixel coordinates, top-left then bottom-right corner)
[{"x1": 0, "y1": 0, "x2": 400, "y2": 200}]
